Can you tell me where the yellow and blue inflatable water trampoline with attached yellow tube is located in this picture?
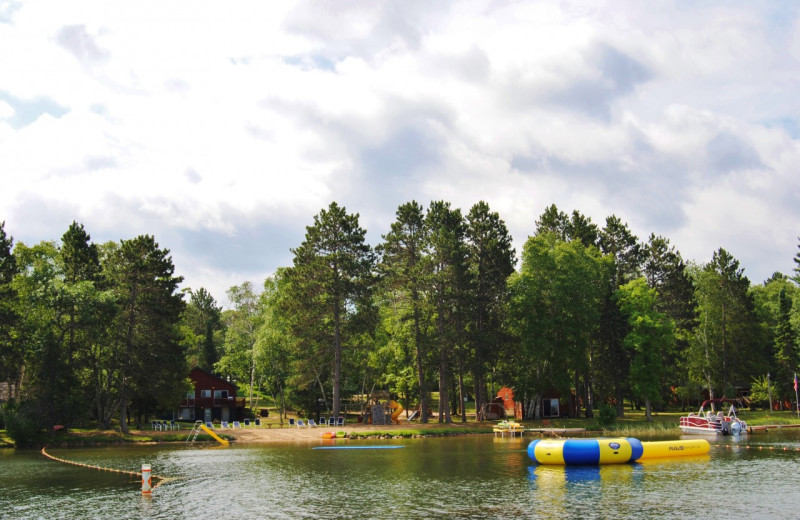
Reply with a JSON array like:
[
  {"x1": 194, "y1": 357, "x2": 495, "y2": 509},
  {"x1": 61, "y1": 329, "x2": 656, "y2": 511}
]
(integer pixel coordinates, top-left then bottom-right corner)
[{"x1": 528, "y1": 437, "x2": 710, "y2": 466}]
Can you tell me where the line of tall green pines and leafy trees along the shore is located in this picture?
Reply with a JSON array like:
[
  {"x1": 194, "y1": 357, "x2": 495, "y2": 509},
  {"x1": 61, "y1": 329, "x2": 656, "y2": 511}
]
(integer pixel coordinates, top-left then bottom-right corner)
[{"x1": 0, "y1": 201, "x2": 800, "y2": 442}]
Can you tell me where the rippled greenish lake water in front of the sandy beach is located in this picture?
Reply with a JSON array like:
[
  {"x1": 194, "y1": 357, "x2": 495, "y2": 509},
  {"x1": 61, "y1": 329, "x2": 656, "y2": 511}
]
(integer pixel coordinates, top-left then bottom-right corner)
[{"x1": 0, "y1": 430, "x2": 800, "y2": 520}]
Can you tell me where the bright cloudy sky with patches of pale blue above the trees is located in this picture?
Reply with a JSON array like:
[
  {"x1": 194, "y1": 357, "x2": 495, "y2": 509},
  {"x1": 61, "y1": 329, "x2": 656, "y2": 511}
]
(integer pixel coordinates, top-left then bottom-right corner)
[{"x1": 0, "y1": 0, "x2": 800, "y2": 305}]
